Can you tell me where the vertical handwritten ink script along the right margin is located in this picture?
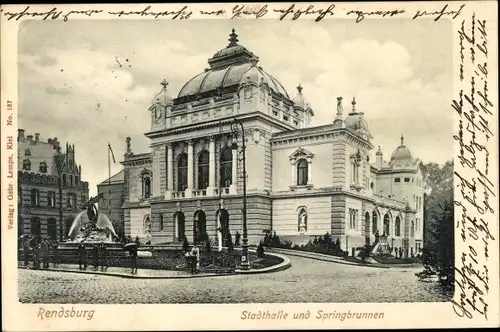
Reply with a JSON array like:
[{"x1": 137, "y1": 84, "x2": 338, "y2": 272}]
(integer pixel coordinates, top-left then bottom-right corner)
[{"x1": 452, "y1": 14, "x2": 498, "y2": 319}]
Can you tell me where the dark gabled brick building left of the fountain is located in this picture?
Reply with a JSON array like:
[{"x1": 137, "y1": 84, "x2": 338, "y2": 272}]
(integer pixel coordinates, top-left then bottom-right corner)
[{"x1": 17, "y1": 129, "x2": 89, "y2": 241}]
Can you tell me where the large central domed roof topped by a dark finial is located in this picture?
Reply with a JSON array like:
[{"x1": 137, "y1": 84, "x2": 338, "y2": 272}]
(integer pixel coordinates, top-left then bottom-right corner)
[{"x1": 178, "y1": 29, "x2": 289, "y2": 99}]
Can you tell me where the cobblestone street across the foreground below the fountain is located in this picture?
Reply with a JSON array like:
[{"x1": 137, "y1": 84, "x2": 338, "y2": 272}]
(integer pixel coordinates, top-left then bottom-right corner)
[{"x1": 18, "y1": 256, "x2": 448, "y2": 304}]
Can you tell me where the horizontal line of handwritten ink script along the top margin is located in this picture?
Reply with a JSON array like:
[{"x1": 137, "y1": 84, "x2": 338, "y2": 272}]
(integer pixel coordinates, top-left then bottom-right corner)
[{"x1": 0, "y1": 4, "x2": 465, "y2": 23}]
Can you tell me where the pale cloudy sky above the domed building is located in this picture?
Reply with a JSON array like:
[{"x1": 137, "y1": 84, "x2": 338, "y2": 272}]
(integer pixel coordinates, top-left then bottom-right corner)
[{"x1": 18, "y1": 18, "x2": 453, "y2": 195}]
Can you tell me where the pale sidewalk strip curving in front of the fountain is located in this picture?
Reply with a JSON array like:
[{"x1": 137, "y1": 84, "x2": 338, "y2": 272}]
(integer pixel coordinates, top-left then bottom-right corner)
[{"x1": 18, "y1": 264, "x2": 223, "y2": 279}]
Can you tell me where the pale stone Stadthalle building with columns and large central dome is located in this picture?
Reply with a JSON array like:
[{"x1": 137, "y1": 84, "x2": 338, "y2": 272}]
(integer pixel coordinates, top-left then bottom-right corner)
[{"x1": 123, "y1": 30, "x2": 424, "y2": 255}]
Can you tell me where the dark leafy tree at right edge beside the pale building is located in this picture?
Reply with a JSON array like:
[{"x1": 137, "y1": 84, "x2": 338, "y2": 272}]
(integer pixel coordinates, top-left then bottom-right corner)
[{"x1": 422, "y1": 161, "x2": 455, "y2": 285}]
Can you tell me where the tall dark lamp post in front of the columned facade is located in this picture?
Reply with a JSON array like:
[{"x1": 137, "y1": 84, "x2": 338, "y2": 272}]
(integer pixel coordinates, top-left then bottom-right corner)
[{"x1": 231, "y1": 118, "x2": 250, "y2": 270}]
